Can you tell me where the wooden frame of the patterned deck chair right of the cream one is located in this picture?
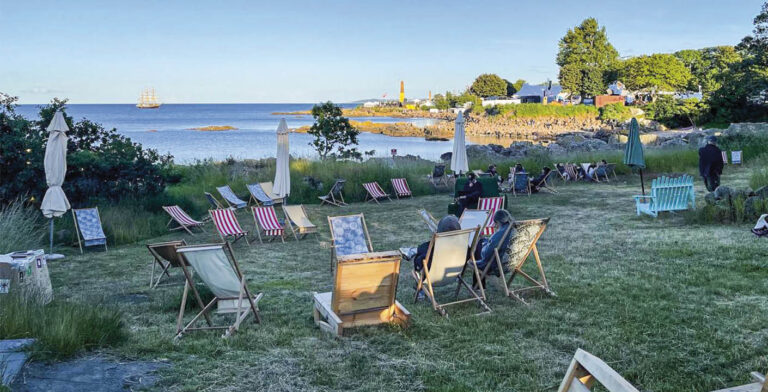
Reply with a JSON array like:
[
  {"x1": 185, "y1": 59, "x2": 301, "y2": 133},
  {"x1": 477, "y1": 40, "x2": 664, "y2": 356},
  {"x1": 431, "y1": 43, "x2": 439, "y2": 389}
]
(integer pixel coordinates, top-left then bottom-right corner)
[{"x1": 481, "y1": 218, "x2": 557, "y2": 305}]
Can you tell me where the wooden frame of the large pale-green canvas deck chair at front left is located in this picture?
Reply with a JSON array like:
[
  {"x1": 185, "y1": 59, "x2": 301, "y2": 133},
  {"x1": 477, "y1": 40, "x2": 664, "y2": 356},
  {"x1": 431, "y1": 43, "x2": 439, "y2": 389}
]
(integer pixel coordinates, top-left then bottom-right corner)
[{"x1": 174, "y1": 242, "x2": 264, "y2": 340}]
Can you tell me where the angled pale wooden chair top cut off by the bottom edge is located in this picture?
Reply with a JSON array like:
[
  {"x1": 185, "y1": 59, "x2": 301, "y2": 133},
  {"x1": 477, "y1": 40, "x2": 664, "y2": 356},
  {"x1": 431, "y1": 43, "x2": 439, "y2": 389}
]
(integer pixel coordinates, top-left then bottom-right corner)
[{"x1": 558, "y1": 349, "x2": 639, "y2": 392}]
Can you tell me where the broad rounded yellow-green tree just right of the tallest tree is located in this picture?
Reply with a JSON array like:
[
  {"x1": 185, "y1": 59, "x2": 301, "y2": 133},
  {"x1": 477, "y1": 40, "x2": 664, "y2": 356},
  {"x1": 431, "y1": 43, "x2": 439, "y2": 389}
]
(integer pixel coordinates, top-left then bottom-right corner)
[{"x1": 619, "y1": 54, "x2": 692, "y2": 99}]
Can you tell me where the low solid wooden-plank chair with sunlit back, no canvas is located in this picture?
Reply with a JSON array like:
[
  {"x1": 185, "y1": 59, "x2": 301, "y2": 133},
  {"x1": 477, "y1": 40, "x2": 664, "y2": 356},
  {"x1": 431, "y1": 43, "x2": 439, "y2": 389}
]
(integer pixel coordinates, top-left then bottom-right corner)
[{"x1": 312, "y1": 251, "x2": 411, "y2": 336}]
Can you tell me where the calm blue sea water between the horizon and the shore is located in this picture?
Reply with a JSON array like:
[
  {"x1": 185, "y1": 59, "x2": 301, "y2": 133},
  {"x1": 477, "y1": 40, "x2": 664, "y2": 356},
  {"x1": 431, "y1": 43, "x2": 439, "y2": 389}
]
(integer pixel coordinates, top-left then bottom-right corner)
[{"x1": 17, "y1": 104, "x2": 460, "y2": 163}]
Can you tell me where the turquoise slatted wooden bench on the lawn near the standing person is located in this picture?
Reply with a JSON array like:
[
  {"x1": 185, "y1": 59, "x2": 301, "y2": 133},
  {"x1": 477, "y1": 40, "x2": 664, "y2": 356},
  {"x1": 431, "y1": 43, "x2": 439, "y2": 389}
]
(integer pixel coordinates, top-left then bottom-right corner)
[{"x1": 635, "y1": 175, "x2": 696, "y2": 218}]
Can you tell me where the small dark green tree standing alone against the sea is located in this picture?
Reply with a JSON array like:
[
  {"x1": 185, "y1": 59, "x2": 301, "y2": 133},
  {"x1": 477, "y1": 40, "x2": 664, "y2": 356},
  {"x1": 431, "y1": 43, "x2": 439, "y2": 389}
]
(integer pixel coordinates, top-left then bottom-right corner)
[{"x1": 307, "y1": 101, "x2": 362, "y2": 159}]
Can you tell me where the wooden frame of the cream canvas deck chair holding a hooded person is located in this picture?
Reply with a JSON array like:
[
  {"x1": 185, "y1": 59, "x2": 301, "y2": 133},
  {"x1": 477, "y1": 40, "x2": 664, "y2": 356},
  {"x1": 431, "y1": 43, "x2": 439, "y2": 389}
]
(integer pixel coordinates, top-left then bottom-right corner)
[{"x1": 411, "y1": 228, "x2": 491, "y2": 317}]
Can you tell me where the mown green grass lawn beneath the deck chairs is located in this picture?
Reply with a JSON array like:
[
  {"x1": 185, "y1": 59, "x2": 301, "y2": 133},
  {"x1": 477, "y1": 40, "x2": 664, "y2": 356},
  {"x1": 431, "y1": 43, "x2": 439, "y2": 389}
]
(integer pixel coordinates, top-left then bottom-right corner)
[{"x1": 50, "y1": 167, "x2": 768, "y2": 391}]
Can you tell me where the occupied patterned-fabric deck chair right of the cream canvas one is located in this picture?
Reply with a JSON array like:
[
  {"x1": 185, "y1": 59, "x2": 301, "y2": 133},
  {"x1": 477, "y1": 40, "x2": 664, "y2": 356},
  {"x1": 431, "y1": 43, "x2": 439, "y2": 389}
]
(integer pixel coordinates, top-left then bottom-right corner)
[{"x1": 481, "y1": 218, "x2": 556, "y2": 304}]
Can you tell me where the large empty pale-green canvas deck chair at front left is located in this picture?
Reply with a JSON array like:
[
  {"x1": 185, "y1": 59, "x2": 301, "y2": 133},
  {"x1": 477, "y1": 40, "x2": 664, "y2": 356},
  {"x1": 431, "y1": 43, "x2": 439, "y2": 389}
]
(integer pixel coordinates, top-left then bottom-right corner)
[{"x1": 176, "y1": 242, "x2": 264, "y2": 339}]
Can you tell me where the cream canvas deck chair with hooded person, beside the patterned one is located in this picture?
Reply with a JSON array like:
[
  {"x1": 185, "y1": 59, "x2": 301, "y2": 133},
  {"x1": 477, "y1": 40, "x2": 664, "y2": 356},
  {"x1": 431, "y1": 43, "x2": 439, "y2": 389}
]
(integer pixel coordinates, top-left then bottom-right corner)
[{"x1": 411, "y1": 228, "x2": 491, "y2": 316}]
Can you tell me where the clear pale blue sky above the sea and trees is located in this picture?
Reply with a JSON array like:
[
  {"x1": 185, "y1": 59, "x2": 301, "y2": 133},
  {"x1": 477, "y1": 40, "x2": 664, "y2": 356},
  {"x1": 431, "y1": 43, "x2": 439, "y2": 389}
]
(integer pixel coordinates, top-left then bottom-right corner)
[{"x1": 0, "y1": 0, "x2": 763, "y2": 103}]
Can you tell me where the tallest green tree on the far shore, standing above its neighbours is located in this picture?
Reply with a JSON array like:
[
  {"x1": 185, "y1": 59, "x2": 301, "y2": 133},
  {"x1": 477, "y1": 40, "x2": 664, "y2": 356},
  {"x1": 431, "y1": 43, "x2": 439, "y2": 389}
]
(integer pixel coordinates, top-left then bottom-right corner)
[{"x1": 556, "y1": 18, "x2": 619, "y2": 97}]
